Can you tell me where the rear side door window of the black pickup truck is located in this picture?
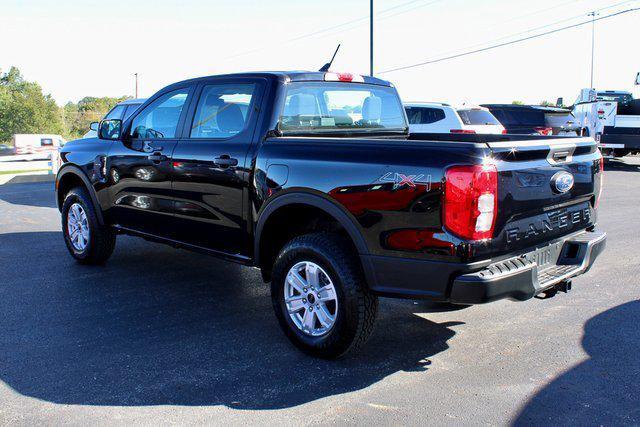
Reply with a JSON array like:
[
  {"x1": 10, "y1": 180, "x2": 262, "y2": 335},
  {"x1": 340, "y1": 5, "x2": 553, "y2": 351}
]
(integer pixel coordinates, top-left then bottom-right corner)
[{"x1": 191, "y1": 83, "x2": 256, "y2": 138}]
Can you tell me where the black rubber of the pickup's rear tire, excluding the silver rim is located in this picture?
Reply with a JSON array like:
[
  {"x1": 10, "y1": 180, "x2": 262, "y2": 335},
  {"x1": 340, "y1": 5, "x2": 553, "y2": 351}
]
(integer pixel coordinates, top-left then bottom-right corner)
[{"x1": 271, "y1": 233, "x2": 378, "y2": 359}]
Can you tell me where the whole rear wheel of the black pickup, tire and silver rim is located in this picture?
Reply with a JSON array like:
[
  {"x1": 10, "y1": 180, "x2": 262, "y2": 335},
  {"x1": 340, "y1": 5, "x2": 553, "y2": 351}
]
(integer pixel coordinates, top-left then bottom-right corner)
[{"x1": 271, "y1": 233, "x2": 378, "y2": 359}]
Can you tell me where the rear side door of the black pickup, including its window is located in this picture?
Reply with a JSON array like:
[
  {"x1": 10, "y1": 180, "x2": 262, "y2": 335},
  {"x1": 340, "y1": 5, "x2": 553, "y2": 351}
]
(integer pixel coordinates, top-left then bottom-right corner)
[{"x1": 173, "y1": 79, "x2": 266, "y2": 257}]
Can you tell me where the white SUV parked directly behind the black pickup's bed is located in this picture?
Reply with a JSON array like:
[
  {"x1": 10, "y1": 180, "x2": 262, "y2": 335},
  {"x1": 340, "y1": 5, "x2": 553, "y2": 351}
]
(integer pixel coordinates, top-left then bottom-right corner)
[{"x1": 404, "y1": 102, "x2": 506, "y2": 134}]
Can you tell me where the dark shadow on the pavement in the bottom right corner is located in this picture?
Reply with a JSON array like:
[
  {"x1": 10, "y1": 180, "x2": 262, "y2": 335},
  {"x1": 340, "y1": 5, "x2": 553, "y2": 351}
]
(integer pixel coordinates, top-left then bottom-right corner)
[{"x1": 515, "y1": 301, "x2": 640, "y2": 425}]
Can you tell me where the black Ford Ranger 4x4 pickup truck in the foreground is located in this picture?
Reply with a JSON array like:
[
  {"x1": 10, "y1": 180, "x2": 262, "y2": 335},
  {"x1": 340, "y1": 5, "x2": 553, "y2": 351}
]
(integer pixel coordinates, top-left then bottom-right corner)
[{"x1": 56, "y1": 72, "x2": 605, "y2": 358}]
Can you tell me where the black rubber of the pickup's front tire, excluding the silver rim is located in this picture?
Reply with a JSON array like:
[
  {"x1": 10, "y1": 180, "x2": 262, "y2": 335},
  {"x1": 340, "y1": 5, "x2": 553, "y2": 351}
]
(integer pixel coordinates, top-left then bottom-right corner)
[{"x1": 62, "y1": 187, "x2": 116, "y2": 265}]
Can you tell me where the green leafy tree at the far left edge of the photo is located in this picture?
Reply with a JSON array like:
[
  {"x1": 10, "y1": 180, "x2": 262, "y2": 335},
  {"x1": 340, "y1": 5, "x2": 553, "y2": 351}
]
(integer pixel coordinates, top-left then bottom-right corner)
[{"x1": 0, "y1": 67, "x2": 64, "y2": 142}]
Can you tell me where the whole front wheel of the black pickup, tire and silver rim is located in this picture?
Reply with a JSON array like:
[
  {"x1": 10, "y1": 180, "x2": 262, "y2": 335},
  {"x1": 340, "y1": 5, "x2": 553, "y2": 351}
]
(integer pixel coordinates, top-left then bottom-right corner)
[{"x1": 62, "y1": 187, "x2": 116, "y2": 264}]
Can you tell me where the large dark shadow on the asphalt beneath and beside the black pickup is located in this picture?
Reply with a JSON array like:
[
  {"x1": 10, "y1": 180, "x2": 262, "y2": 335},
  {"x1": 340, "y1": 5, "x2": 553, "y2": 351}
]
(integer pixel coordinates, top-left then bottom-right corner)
[{"x1": 0, "y1": 233, "x2": 460, "y2": 409}]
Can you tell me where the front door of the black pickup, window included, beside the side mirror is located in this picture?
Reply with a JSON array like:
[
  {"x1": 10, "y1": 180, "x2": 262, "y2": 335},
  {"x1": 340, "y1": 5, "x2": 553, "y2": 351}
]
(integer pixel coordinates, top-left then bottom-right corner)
[{"x1": 107, "y1": 87, "x2": 190, "y2": 238}]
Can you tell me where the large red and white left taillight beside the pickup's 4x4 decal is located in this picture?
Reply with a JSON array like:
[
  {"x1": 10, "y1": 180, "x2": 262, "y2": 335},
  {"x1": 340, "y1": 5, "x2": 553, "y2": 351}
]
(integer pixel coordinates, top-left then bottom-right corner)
[{"x1": 443, "y1": 165, "x2": 498, "y2": 240}]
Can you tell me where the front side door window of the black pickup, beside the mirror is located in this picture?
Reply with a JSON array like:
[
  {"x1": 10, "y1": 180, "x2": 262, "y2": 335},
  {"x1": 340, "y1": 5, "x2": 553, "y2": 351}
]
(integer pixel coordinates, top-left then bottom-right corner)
[{"x1": 129, "y1": 88, "x2": 189, "y2": 139}]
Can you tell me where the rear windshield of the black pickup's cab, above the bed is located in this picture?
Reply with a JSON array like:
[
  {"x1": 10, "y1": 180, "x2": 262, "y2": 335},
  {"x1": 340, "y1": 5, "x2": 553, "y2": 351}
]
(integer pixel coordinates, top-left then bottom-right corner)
[{"x1": 278, "y1": 82, "x2": 407, "y2": 134}]
